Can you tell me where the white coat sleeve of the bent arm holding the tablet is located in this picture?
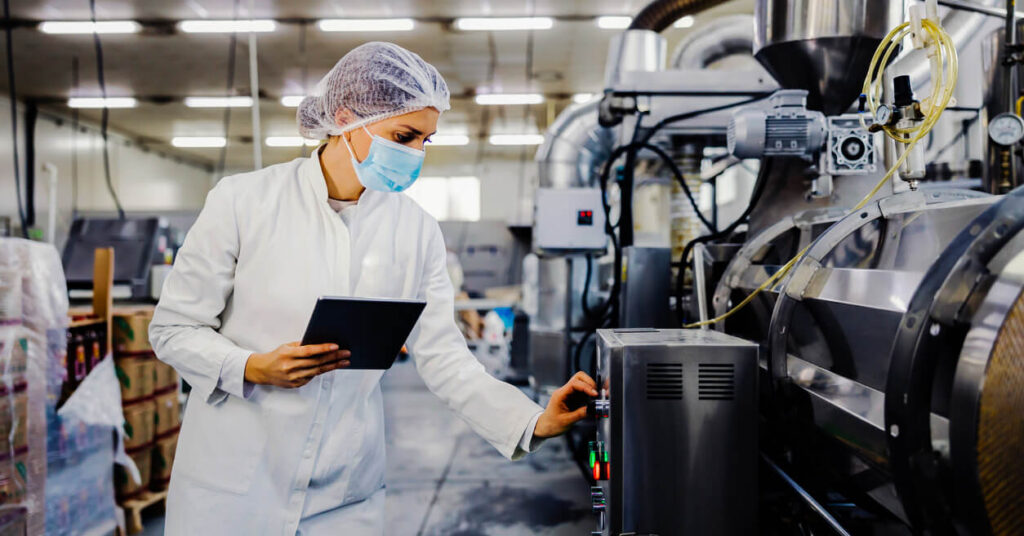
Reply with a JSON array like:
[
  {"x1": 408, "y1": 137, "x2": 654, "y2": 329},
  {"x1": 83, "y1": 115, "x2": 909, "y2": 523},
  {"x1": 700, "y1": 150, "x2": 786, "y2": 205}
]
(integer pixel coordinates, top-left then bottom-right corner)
[{"x1": 150, "y1": 181, "x2": 252, "y2": 404}]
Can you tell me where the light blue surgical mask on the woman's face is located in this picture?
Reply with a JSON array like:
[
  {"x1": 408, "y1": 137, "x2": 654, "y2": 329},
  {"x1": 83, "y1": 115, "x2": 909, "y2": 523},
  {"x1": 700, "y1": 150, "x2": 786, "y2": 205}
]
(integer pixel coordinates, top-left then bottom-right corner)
[{"x1": 342, "y1": 127, "x2": 424, "y2": 192}]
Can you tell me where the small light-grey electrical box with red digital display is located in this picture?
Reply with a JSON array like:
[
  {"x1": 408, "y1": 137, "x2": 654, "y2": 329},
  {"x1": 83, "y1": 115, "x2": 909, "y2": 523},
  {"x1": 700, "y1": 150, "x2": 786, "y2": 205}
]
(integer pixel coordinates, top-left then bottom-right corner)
[{"x1": 534, "y1": 188, "x2": 608, "y2": 254}]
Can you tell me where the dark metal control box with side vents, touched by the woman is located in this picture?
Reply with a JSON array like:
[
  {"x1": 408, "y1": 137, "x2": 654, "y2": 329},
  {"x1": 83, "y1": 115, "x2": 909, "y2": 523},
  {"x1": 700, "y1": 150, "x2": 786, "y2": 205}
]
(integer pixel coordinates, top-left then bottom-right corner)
[{"x1": 591, "y1": 329, "x2": 758, "y2": 536}]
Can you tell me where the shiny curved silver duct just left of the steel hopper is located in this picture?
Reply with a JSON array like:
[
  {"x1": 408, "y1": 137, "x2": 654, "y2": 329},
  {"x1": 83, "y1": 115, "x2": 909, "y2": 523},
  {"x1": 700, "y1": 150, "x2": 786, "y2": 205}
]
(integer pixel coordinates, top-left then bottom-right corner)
[{"x1": 669, "y1": 14, "x2": 754, "y2": 69}]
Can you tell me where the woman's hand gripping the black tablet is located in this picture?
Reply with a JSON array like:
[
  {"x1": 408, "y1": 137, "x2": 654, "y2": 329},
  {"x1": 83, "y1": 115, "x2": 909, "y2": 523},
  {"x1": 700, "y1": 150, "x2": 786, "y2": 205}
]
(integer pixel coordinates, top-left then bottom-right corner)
[{"x1": 246, "y1": 342, "x2": 352, "y2": 387}]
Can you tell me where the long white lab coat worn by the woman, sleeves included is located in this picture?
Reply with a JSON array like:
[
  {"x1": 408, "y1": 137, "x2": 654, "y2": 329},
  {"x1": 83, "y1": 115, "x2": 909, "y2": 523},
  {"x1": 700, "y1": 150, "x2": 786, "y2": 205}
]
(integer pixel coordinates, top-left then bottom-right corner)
[{"x1": 150, "y1": 153, "x2": 542, "y2": 536}]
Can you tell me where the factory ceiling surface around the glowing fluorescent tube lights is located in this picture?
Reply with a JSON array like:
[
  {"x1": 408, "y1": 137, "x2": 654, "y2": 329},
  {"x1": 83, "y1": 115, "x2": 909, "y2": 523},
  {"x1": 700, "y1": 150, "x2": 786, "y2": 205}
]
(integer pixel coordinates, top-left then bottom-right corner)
[{"x1": 0, "y1": 0, "x2": 753, "y2": 169}]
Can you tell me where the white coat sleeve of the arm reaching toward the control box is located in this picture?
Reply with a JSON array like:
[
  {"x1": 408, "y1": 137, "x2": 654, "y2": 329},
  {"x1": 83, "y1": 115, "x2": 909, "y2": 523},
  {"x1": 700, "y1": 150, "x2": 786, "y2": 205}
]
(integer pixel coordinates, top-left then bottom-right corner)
[{"x1": 409, "y1": 222, "x2": 543, "y2": 459}]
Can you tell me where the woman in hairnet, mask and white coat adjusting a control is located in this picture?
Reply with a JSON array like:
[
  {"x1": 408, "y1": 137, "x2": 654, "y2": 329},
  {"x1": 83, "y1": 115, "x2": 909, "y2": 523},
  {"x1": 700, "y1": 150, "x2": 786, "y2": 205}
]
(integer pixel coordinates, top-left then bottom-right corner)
[{"x1": 150, "y1": 39, "x2": 597, "y2": 536}]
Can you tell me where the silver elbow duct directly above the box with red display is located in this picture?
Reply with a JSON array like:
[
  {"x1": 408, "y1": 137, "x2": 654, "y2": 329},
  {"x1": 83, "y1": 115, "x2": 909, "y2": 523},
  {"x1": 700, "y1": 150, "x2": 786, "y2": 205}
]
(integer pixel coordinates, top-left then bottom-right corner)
[{"x1": 536, "y1": 100, "x2": 615, "y2": 188}]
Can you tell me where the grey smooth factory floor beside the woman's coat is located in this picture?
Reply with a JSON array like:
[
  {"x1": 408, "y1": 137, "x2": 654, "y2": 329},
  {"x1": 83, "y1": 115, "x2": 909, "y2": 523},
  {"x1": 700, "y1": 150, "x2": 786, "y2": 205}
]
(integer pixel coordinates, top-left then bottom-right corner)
[{"x1": 144, "y1": 361, "x2": 596, "y2": 536}]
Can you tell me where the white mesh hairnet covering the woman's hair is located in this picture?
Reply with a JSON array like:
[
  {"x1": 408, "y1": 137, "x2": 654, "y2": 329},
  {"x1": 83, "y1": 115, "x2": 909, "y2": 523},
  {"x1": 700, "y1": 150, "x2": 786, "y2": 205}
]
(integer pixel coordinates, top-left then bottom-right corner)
[{"x1": 295, "y1": 42, "x2": 451, "y2": 139}]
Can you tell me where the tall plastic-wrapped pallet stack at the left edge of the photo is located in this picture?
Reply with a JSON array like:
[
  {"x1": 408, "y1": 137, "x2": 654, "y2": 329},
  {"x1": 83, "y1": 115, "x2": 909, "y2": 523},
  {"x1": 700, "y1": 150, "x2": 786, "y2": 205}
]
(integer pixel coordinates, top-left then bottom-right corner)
[{"x1": 0, "y1": 239, "x2": 120, "y2": 536}]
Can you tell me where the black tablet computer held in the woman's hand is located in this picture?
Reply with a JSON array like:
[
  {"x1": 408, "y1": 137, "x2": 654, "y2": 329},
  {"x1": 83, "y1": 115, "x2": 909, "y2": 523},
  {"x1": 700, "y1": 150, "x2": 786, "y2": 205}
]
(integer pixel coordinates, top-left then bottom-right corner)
[{"x1": 302, "y1": 296, "x2": 427, "y2": 370}]
